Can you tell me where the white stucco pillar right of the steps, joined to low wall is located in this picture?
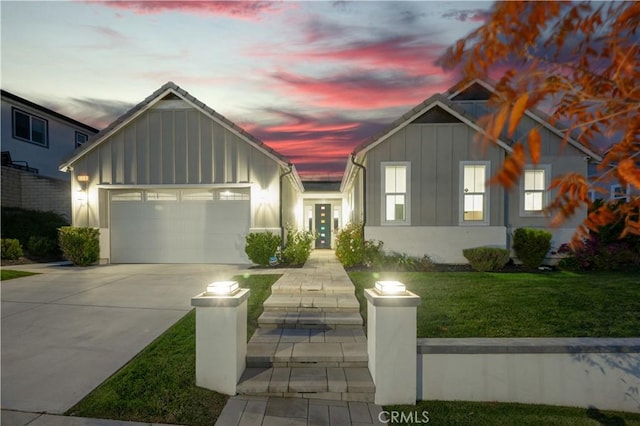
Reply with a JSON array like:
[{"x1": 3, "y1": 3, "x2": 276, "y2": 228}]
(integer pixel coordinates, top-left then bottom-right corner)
[{"x1": 364, "y1": 289, "x2": 420, "y2": 405}]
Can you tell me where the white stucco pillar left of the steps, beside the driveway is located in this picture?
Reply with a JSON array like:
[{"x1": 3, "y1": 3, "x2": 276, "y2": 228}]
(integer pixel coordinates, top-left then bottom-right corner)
[{"x1": 191, "y1": 289, "x2": 249, "y2": 395}]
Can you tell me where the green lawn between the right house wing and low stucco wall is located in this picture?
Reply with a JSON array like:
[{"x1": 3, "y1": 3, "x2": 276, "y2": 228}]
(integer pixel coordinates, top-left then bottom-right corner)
[{"x1": 349, "y1": 272, "x2": 640, "y2": 337}]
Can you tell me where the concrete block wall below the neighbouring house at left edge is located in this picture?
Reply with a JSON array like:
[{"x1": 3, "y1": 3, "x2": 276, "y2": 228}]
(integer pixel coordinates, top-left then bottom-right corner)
[{"x1": 1, "y1": 167, "x2": 71, "y2": 221}]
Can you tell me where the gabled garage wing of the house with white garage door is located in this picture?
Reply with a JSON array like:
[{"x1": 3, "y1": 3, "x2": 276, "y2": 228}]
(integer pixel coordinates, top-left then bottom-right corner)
[{"x1": 60, "y1": 82, "x2": 303, "y2": 264}]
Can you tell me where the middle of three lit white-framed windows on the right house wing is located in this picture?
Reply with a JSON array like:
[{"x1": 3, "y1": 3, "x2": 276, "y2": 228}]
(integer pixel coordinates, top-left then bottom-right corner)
[{"x1": 461, "y1": 162, "x2": 489, "y2": 225}]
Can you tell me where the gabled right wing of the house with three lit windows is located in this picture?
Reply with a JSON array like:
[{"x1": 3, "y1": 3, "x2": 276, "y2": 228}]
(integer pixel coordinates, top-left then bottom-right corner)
[{"x1": 341, "y1": 80, "x2": 601, "y2": 264}]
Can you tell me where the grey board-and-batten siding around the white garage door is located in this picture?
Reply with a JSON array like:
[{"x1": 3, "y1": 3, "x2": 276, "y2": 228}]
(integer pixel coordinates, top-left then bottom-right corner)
[{"x1": 72, "y1": 101, "x2": 281, "y2": 228}]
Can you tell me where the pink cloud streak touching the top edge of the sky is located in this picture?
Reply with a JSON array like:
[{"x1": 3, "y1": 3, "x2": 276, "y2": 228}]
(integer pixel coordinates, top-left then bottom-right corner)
[{"x1": 97, "y1": 0, "x2": 281, "y2": 19}]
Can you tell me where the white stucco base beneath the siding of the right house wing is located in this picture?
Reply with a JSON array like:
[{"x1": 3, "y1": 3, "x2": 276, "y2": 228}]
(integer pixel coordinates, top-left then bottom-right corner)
[{"x1": 365, "y1": 226, "x2": 507, "y2": 264}]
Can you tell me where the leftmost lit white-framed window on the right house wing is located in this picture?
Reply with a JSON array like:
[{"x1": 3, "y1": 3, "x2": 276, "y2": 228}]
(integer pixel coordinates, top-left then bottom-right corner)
[{"x1": 382, "y1": 163, "x2": 409, "y2": 224}]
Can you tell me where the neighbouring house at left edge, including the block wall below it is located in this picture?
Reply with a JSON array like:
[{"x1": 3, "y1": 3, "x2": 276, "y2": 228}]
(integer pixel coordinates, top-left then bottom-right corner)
[{"x1": 0, "y1": 90, "x2": 98, "y2": 218}]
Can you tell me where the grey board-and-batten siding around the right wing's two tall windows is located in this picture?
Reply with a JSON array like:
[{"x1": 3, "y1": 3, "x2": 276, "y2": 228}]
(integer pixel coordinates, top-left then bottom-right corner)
[{"x1": 367, "y1": 123, "x2": 504, "y2": 226}]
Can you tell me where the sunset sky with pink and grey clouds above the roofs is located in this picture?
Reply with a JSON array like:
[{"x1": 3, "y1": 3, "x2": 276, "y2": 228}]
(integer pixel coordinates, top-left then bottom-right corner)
[{"x1": 0, "y1": 0, "x2": 492, "y2": 179}]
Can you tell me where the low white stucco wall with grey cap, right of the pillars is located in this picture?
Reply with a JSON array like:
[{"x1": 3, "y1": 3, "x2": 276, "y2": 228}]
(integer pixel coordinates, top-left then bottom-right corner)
[{"x1": 417, "y1": 338, "x2": 640, "y2": 412}]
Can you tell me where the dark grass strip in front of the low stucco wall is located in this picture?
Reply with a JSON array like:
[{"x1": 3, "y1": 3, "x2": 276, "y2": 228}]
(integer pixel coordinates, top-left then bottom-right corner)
[{"x1": 385, "y1": 401, "x2": 640, "y2": 426}]
